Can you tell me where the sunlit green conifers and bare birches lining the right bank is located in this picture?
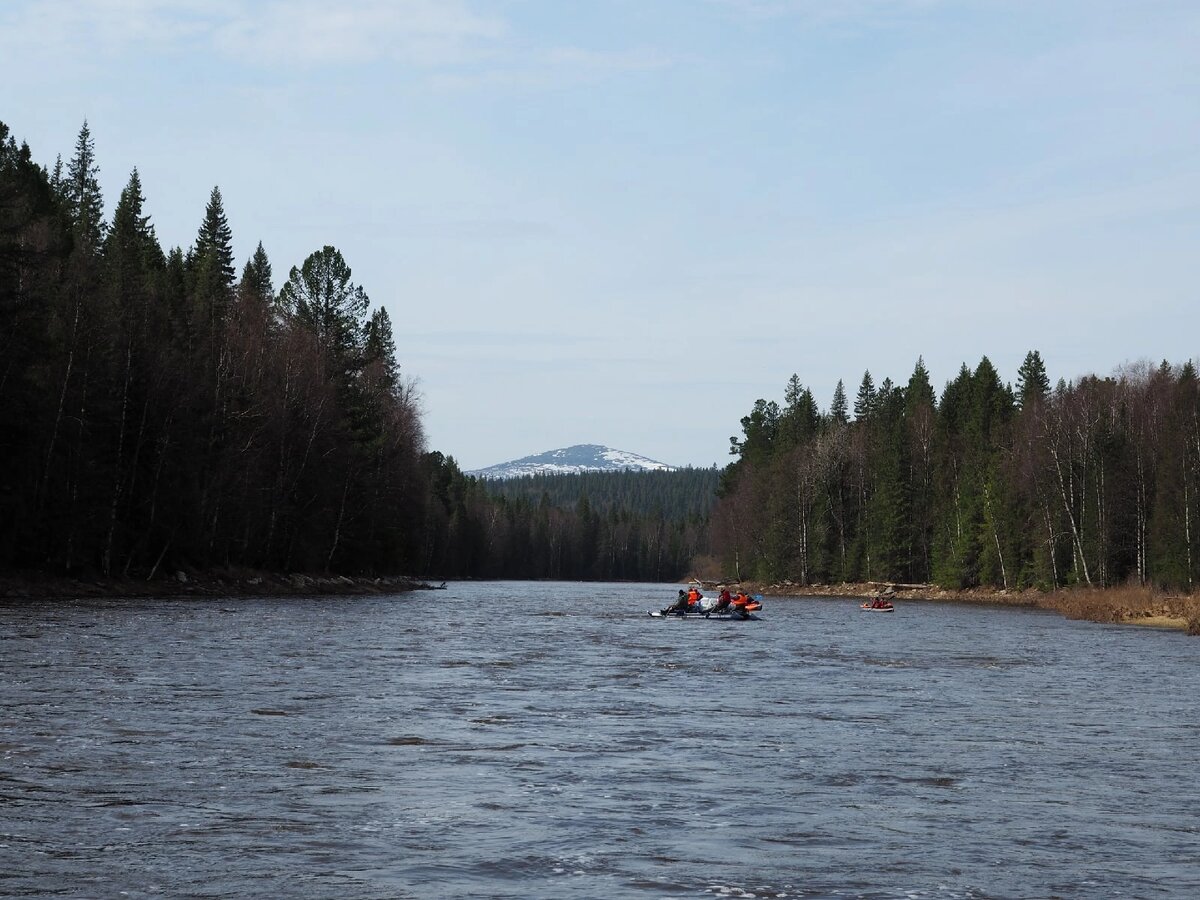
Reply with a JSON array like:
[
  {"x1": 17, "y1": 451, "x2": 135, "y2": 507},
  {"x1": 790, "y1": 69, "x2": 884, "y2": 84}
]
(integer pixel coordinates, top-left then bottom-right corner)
[{"x1": 713, "y1": 352, "x2": 1200, "y2": 592}]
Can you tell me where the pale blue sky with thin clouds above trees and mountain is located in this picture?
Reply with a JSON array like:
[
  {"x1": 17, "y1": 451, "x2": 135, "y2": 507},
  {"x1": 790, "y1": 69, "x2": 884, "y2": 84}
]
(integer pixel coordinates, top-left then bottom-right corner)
[{"x1": 0, "y1": 0, "x2": 1200, "y2": 470}]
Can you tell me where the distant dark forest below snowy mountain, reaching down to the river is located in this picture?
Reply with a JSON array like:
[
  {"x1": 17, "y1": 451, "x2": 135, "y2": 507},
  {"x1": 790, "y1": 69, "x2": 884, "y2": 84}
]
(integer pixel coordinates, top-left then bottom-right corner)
[{"x1": 424, "y1": 454, "x2": 715, "y2": 581}]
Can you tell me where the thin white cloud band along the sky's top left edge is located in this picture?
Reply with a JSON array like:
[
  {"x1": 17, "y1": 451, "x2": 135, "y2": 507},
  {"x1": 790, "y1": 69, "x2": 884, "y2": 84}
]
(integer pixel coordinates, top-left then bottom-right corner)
[{"x1": 0, "y1": 0, "x2": 676, "y2": 88}]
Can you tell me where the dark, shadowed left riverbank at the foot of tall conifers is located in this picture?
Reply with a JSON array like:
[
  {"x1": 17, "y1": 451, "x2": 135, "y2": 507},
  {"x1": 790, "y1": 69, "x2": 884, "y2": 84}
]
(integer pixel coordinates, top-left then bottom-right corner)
[{"x1": 0, "y1": 570, "x2": 445, "y2": 600}]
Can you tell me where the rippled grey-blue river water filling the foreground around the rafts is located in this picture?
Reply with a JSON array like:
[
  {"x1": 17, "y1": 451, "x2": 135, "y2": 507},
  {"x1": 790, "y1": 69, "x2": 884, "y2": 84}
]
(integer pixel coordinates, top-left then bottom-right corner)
[{"x1": 0, "y1": 582, "x2": 1200, "y2": 899}]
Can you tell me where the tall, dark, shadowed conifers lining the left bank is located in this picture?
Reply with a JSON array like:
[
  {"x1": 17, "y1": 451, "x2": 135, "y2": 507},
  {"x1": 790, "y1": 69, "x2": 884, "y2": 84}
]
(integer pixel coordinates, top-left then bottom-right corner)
[{"x1": 0, "y1": 124, "x2": 428, "y2": 576}]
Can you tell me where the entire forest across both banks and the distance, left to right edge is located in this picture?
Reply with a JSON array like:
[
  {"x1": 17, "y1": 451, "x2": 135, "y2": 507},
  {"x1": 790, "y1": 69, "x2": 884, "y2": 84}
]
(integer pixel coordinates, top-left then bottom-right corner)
[{"x1": 0, "y1": 122, "x2": 1200, "y2": 600}]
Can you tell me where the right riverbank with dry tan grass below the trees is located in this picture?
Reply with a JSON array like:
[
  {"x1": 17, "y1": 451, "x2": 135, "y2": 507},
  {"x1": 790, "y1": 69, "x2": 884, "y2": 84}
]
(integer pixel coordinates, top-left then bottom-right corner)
[{"x1": 744, "y1": 582, "x2": 1200, "y2": 635}]
